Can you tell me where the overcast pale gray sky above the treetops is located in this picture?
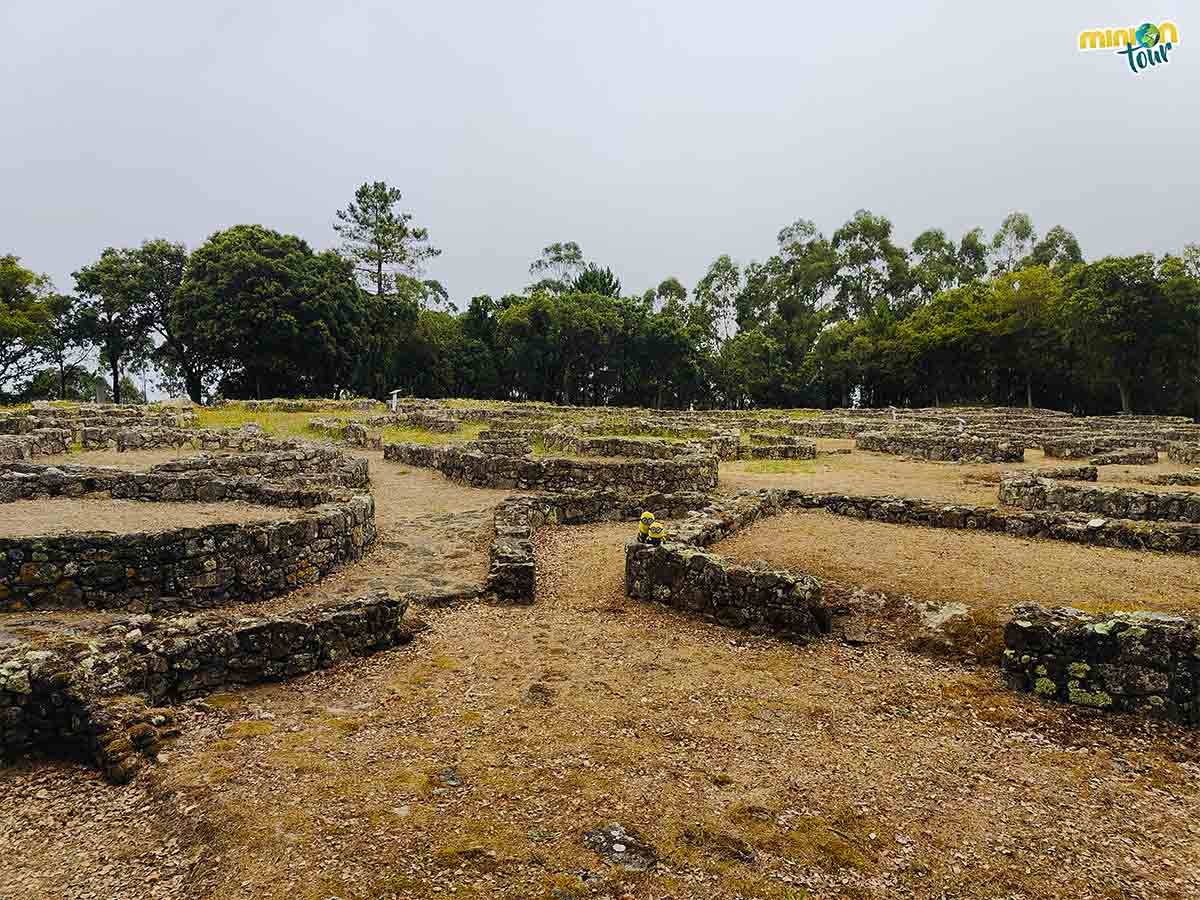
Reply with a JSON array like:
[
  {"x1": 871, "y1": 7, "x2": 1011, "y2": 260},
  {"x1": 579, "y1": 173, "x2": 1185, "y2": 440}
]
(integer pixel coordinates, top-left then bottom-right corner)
[{"x1": 0, "y1": 0, "x2": 1200, "y2": 306}]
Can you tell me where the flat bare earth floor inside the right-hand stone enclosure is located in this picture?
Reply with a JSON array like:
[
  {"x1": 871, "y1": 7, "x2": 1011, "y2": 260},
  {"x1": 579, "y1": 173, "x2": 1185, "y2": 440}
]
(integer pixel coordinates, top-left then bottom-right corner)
[{"x1": 713, "y1": 511, "x2": 1200, "y2": 613}]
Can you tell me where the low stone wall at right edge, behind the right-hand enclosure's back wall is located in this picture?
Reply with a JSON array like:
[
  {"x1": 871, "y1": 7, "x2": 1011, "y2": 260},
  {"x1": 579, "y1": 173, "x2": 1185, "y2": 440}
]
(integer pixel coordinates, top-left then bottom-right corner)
[{"x1": 1000, "y1": 474, "x2": 1200, "y2": 522}]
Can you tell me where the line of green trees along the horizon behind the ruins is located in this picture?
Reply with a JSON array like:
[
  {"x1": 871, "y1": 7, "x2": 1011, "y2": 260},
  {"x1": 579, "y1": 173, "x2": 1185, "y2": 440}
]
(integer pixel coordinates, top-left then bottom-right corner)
[{"x1": 0, "y1": 190, "x2": 1200, "y2": 415}]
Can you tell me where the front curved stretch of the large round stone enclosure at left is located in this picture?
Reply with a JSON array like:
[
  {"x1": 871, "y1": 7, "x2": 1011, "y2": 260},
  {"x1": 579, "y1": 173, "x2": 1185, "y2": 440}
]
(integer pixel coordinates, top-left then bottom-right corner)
[{"x1": 0, "y1": 494, "x2": 376, "y2": 611}]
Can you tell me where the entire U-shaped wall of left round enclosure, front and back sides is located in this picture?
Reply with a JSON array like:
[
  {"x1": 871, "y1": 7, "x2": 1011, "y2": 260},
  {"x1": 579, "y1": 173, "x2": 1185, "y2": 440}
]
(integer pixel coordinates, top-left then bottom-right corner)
[{"x1": 0, "y1": 448, "x2": 376, "y2": 611}]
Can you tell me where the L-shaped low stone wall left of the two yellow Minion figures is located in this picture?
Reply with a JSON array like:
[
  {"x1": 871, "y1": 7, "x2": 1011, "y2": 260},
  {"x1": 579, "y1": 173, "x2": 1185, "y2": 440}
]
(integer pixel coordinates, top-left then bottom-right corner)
[{"x1": 485, "y1": 491, "x2": 708, "y2": 604}]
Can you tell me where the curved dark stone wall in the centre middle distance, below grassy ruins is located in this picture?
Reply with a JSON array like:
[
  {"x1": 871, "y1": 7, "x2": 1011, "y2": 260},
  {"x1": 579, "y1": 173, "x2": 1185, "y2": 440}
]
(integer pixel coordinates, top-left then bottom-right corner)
[{"x1": 383, "y1": 444, "x2": 718, "y2": 494}]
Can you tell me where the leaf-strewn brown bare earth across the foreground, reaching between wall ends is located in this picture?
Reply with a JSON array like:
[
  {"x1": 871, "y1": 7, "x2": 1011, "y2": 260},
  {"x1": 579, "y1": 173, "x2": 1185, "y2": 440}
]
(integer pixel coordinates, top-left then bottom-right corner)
[{"x1": 0, "y1": 524, "x2": 1200, "y2": 900}]
